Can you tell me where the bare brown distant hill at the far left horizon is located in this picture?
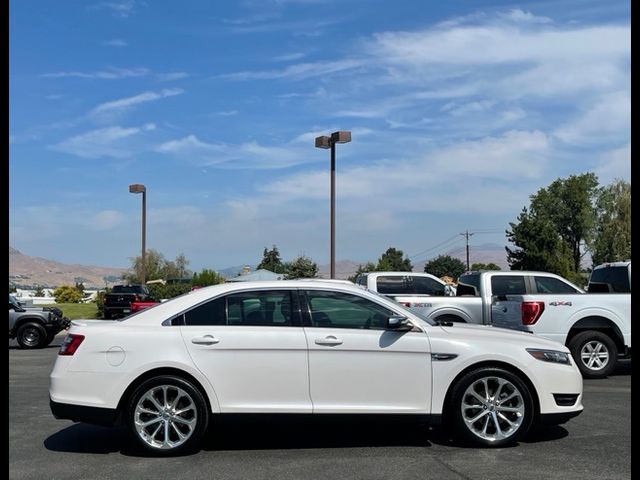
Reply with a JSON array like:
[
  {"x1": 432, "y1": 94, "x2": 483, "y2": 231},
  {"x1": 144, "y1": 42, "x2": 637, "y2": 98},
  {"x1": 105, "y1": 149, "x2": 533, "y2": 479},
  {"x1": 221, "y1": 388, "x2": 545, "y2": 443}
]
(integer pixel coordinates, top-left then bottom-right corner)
[{"x1": 9, "y1": 246, "x2": 127, "y2": 288}]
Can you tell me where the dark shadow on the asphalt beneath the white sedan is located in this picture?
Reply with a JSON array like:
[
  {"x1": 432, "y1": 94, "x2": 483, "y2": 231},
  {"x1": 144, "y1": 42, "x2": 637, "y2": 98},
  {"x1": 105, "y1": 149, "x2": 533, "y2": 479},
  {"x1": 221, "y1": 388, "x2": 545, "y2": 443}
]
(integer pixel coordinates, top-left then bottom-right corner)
[{"x1": 44, "y1": 415, "x2": 568, "y2": 456}]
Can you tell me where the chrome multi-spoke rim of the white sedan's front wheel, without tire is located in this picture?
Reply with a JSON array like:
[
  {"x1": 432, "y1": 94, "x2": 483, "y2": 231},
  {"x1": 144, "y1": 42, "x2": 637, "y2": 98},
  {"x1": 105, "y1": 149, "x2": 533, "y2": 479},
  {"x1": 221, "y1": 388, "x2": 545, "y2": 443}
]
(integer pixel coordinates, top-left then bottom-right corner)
[{"x1": 460, "y1": 377, "x2": 525, "y2": 442}]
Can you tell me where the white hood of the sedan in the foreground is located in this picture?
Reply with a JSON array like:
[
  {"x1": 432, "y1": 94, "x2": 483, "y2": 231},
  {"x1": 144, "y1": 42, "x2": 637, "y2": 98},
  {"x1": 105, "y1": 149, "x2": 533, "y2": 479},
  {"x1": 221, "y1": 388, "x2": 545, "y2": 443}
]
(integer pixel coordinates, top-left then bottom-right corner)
[{"x1": 439, "y1": 323, "x2": 569, "y2": 352}]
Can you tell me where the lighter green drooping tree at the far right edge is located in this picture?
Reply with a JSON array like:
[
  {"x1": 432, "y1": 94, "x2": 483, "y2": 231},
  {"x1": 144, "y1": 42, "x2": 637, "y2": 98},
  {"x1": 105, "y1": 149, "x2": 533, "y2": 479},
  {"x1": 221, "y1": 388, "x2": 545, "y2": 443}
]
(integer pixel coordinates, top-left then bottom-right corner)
[{"x1": 591, "y1": 180, "x2": 631, "y2": 265}]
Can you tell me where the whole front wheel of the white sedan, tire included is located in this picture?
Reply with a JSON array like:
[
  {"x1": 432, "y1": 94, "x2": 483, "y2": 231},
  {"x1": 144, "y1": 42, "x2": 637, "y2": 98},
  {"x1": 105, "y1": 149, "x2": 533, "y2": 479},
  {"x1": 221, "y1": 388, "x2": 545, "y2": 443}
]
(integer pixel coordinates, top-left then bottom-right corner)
[{"x1": 446, "y1": 367, "x2": 534, "y2": 447}]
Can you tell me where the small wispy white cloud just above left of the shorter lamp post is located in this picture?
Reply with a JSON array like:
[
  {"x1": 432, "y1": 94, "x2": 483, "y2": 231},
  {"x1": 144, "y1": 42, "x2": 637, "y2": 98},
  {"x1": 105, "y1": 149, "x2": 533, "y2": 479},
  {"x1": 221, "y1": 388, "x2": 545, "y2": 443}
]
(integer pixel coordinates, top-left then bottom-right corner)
[{"x1": 50, "y1": 123, "x2": 156, "y2": 158}]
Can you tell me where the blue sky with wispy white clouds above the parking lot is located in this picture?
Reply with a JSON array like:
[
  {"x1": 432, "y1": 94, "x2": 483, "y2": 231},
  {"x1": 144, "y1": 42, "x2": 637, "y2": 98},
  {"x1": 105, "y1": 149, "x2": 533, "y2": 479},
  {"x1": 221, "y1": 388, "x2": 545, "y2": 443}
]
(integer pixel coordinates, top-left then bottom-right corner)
[{"x1": 9, "y1": 0, "x2": 631, "y2": 269}]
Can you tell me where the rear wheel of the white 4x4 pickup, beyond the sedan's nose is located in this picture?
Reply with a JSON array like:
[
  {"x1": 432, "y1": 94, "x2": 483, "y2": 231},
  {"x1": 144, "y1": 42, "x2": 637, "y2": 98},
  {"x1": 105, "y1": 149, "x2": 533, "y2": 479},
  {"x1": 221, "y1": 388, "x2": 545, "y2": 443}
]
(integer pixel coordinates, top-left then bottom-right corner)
[{"x1": 569, "y1": 330, "x2": 618, "y2": 378}]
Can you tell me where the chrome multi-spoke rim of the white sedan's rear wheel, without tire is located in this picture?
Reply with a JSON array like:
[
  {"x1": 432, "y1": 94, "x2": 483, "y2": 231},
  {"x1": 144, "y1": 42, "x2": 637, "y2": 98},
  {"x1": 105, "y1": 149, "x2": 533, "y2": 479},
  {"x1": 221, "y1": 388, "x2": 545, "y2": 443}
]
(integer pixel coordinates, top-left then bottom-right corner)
[{"x1": 134, "y1": 385, "x2": 198, "y2": 450}]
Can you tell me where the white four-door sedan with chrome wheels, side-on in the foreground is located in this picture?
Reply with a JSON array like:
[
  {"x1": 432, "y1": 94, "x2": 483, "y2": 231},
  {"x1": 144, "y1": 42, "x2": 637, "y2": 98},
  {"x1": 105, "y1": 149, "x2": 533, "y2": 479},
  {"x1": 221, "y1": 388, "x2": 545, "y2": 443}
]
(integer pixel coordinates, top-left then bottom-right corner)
[{"x1": 49, "y1": 280, "x2": 583, "y2": 455}]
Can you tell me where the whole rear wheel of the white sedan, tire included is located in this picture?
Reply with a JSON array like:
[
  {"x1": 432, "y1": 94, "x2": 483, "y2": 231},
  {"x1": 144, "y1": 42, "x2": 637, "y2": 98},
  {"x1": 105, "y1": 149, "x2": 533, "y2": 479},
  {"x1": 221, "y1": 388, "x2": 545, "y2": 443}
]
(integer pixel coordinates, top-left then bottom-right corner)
[{"x1": 127, "y1": 375, "x2": 209, "y2": 456}]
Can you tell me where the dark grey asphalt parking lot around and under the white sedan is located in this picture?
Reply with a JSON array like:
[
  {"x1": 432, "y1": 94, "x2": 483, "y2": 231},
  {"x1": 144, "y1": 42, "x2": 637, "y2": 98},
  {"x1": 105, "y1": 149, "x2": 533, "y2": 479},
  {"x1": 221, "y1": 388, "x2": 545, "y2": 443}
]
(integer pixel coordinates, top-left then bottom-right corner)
[{"x1": 9, "y1": 337, "x2": 631, "y2": 480}]
